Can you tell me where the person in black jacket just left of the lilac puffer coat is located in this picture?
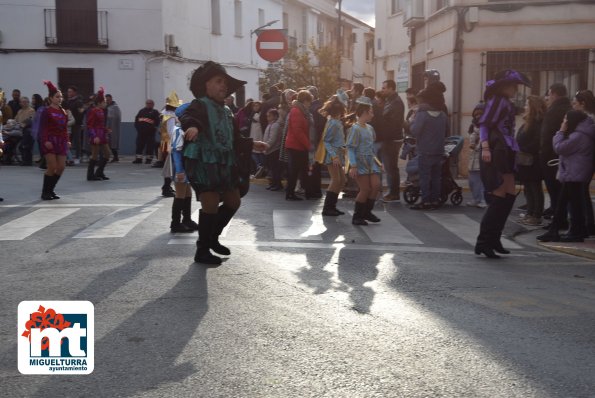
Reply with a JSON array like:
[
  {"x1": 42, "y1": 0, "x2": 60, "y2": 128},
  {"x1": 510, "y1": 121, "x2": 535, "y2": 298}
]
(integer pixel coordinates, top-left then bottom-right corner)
[{"x1": 539, "y1": 83, "x2": 572, "y2": 216}]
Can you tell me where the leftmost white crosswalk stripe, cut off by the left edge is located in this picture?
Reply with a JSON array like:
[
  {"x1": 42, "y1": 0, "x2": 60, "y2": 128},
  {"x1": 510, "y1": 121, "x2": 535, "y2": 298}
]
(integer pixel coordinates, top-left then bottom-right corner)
[{"x1": 0, "y1": 208, "x2": 79, "y2": 240}]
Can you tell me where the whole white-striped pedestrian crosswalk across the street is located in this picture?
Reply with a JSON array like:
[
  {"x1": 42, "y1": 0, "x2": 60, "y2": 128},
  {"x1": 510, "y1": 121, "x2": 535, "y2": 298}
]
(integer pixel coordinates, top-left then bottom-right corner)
[{"x1": 0, "y1": 203, "x2": 521, "y2": 253}]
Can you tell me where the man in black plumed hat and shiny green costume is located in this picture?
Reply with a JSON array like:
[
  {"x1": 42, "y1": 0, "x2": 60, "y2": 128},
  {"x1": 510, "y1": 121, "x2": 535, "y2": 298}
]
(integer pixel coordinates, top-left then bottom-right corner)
[{"x1": 180, "y1": 61, "x2": 267, "y2": 265}]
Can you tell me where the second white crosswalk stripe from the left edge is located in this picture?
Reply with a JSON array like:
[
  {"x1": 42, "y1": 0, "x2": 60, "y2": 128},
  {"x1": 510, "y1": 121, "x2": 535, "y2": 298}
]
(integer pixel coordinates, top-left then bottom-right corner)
[{"x1": 74, "y1": 206, "x2": 159, "y2": 239}]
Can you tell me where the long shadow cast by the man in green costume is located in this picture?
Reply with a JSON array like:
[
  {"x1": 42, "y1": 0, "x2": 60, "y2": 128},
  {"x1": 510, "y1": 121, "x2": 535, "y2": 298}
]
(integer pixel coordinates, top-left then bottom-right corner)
[{"x1": 33, "y1": 265, "x2": 208, "y2": 398}]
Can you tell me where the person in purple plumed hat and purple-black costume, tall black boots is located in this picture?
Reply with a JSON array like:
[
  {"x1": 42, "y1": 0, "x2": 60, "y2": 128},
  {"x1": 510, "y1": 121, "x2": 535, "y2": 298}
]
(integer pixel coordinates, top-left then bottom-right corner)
[{"x1": 475, "y1": 69, "x2": 531, "y2": 258}]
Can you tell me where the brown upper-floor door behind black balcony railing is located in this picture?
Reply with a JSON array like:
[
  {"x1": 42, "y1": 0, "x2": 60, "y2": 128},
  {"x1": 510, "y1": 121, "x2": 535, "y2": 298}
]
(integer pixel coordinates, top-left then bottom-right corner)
[{"x1": 56, "y1": 0, "x2": 98, "y2": 46}]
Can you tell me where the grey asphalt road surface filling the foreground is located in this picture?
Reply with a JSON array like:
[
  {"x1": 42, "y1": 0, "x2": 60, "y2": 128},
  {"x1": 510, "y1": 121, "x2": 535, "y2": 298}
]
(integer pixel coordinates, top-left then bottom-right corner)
[{"x1": 0, "y1": 161, "x2": 595, "y2": 397}]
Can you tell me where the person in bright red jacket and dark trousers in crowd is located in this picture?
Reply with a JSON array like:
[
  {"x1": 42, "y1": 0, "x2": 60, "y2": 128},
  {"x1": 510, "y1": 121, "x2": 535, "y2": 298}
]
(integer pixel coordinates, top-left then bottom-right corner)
[{"x1": 285, "y1": 90, "x2": 314, "y2": 200}]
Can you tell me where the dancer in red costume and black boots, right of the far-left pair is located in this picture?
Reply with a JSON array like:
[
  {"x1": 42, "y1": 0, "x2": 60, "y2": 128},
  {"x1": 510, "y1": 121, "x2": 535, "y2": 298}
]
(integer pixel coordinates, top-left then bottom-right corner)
[{"x1": 87, "y1": 87, "x2": 112, "y2": 181}]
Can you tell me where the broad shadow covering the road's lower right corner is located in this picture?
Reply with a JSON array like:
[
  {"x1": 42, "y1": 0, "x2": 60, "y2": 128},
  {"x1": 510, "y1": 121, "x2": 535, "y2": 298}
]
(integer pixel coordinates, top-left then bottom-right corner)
[{"x1": 389, "y1": 254, "x2": 595, "y2": 397}]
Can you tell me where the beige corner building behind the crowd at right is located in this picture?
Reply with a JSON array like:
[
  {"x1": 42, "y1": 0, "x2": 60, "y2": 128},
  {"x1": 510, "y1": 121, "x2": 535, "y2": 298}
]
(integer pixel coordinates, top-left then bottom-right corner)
[{"x1": 376, "y1": 0, "x2": 595, "y2": 174}]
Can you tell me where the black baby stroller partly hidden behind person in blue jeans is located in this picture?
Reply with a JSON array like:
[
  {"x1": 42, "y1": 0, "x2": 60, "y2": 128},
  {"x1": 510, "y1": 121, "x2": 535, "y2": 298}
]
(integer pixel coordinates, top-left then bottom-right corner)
[{"x1": 401, "y1": 136, "x2": 464, "y2": 206}]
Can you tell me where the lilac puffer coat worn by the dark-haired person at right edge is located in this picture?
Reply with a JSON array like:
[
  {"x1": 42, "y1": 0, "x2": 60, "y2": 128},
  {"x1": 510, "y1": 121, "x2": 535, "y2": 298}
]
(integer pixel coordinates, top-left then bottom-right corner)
[{"x1": 553, "y1": 117, "x2": 595, "y2": 182}]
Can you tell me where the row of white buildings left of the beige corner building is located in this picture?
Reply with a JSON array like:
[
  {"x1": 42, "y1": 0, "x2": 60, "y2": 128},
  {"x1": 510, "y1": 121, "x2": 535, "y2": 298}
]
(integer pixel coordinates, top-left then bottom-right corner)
[{"x1": 0, "y1": 0, "x2": 371, "y2": 154}]
